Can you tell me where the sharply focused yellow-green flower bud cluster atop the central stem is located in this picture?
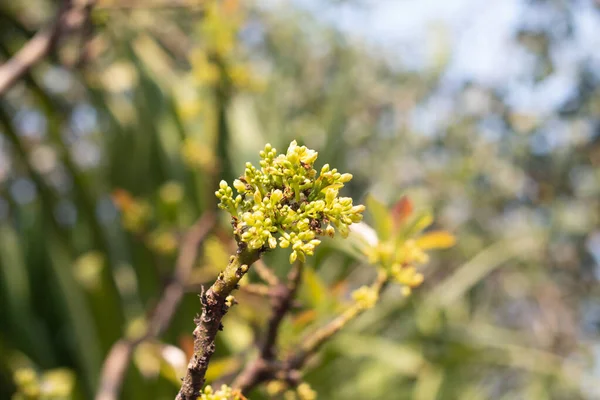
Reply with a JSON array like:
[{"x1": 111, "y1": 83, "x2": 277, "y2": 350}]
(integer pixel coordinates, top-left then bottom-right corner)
[{"x1": 215, "y1": 141, "x2": 365, "y2": 263}]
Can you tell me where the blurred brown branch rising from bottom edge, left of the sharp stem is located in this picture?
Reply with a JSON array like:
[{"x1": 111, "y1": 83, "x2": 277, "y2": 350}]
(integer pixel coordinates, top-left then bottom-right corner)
[{"x1": 96, "y1": 212, "x2": 216, "y2": 400}]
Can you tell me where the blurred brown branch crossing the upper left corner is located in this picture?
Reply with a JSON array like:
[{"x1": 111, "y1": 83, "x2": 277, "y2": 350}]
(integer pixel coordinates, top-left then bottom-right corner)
[{"x1": 0, "y1": 0, "x2": 95, "y2": 96}]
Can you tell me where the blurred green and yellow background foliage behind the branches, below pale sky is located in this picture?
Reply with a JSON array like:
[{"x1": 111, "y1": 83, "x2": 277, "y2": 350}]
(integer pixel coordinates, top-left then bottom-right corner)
[{"x1": 0, "y1": 0, "x2": 600, "y2": 400}]
